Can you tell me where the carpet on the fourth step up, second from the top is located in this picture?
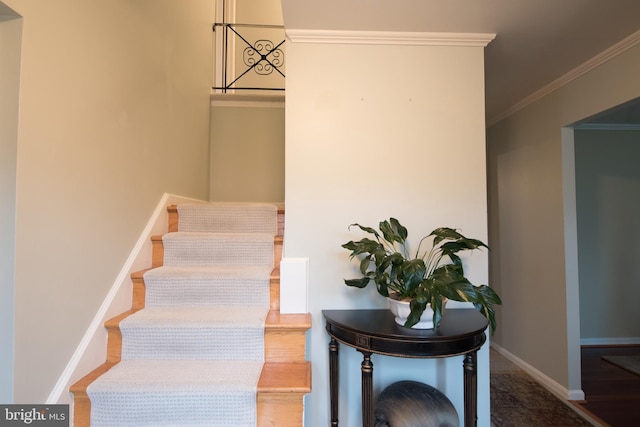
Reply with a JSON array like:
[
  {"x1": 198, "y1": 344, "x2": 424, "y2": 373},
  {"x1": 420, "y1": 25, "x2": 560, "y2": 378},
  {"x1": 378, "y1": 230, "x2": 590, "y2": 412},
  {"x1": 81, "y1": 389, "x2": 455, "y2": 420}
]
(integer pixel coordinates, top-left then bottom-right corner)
[{"x1": 162, "y1": 231, "x2": 274, "y2": 268}]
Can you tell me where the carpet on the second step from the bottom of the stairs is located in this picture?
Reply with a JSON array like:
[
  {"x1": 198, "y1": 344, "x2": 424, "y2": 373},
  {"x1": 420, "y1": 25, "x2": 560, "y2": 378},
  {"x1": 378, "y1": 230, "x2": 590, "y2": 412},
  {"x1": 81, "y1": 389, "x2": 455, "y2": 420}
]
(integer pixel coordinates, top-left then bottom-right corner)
[{"x1": 120, "y1": 307, "x2": 268, "y2": 360}]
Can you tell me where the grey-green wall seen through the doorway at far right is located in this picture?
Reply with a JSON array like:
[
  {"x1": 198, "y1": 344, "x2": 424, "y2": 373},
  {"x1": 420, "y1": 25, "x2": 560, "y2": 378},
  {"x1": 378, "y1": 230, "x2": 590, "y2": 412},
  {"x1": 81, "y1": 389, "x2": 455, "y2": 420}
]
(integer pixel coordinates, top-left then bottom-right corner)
[{"x1": 575, "y1": 128, "x2": 640, "y2": 343}]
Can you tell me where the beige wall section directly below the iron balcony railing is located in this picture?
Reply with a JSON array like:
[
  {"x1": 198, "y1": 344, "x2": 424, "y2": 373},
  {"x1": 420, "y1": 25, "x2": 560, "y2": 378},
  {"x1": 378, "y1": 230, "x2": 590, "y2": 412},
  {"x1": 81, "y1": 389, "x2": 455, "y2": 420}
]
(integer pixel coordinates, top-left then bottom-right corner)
[{"x1": 210, "y1": 101, "x2": 284, "y2": 202}]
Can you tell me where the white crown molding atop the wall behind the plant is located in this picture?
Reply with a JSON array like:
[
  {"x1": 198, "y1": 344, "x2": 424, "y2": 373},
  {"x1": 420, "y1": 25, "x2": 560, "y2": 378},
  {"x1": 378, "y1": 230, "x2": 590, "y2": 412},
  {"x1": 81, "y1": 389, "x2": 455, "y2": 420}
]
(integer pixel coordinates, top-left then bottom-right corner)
[{"x1": 285, "y1": 29, "x2": 496, "y2": 47}]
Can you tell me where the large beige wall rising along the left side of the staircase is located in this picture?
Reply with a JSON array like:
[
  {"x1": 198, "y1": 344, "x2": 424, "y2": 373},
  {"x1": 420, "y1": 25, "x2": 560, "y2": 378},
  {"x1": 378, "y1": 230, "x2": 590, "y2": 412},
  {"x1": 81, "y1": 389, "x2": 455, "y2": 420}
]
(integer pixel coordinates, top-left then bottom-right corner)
[{"x1": 5, "y1": 0, "x2": 213, "y2": 403}]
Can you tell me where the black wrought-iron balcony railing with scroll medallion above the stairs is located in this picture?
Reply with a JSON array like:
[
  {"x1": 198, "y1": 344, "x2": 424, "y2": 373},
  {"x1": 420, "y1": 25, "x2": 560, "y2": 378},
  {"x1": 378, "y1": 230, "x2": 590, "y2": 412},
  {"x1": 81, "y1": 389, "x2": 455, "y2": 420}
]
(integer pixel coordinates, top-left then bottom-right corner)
[{"x1": 213, "y1": 23, "x2": 285, "y2": 93}]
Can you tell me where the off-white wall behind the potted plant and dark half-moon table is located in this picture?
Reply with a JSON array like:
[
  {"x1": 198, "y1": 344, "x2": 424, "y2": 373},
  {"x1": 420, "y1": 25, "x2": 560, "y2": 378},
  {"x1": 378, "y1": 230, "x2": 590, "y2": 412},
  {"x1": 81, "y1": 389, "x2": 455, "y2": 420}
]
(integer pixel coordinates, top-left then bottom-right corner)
[{"x1": 284, "y1": 34, "x2": 492, "y2": 426}]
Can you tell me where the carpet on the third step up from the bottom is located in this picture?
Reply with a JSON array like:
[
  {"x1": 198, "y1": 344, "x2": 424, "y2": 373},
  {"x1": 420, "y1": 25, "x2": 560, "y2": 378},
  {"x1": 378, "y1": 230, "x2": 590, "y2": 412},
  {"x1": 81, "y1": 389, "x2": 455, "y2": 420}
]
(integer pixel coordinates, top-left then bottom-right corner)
[{"x1": 144, "y1": 266, "x2": 273, "y2": 307}]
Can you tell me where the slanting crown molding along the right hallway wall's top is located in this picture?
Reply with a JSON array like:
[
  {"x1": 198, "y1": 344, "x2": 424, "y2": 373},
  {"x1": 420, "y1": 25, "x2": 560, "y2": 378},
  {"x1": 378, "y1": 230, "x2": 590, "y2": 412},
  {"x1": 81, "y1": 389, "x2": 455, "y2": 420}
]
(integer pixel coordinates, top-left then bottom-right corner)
[{"x1": 487, "y1": 30, "x2": 640, "y2": 126}]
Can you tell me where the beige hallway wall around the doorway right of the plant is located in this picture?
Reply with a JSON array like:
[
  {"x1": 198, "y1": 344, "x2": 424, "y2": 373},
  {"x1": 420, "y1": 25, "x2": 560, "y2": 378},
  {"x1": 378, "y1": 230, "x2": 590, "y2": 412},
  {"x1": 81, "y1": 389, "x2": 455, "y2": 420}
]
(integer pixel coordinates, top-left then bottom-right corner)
[{"x1": 487, "y1": 41, "x2": 640, "y2": 391}]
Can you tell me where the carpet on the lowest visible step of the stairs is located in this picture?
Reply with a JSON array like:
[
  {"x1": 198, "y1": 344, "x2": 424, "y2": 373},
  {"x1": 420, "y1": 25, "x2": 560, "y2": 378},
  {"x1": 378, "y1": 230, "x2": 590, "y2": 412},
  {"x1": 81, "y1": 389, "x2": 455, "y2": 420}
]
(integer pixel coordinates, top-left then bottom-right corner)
[{"x1": 87, "y1": 360, "x2": 263, "y2": 427}]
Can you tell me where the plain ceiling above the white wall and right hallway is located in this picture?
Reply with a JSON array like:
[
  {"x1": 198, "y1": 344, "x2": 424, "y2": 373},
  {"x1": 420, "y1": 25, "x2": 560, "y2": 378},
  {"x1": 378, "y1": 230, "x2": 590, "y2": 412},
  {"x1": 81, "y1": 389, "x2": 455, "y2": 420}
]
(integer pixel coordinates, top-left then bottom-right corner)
[{"x1": 282, "y1": 0, "x2": 640, "y2": 123}]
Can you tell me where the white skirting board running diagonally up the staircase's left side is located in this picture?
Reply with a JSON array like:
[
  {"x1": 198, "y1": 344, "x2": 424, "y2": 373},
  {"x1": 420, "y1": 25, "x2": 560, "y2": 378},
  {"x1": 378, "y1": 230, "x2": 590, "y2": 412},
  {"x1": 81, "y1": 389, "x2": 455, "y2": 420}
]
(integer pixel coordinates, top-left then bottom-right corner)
[{"x1": 46, "y1": 193, "x2": 202, "y2": 413}]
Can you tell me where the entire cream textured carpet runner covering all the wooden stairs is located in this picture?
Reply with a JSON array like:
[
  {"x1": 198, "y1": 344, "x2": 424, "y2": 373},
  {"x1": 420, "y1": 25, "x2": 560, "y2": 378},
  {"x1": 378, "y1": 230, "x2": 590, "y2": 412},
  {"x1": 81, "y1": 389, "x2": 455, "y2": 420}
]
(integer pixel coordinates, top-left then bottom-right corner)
[{"x1": 87, "y1": 203, "x2": 278, "y2": 427}]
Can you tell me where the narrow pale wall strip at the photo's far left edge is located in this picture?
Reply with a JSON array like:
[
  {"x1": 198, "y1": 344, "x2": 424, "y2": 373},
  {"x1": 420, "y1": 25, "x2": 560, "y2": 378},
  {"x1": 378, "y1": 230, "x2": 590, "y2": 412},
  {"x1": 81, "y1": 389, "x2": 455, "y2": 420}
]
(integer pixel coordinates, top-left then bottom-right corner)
[{"x1": 0, "y1": 2, "x2": 22, "y2": 403}]
